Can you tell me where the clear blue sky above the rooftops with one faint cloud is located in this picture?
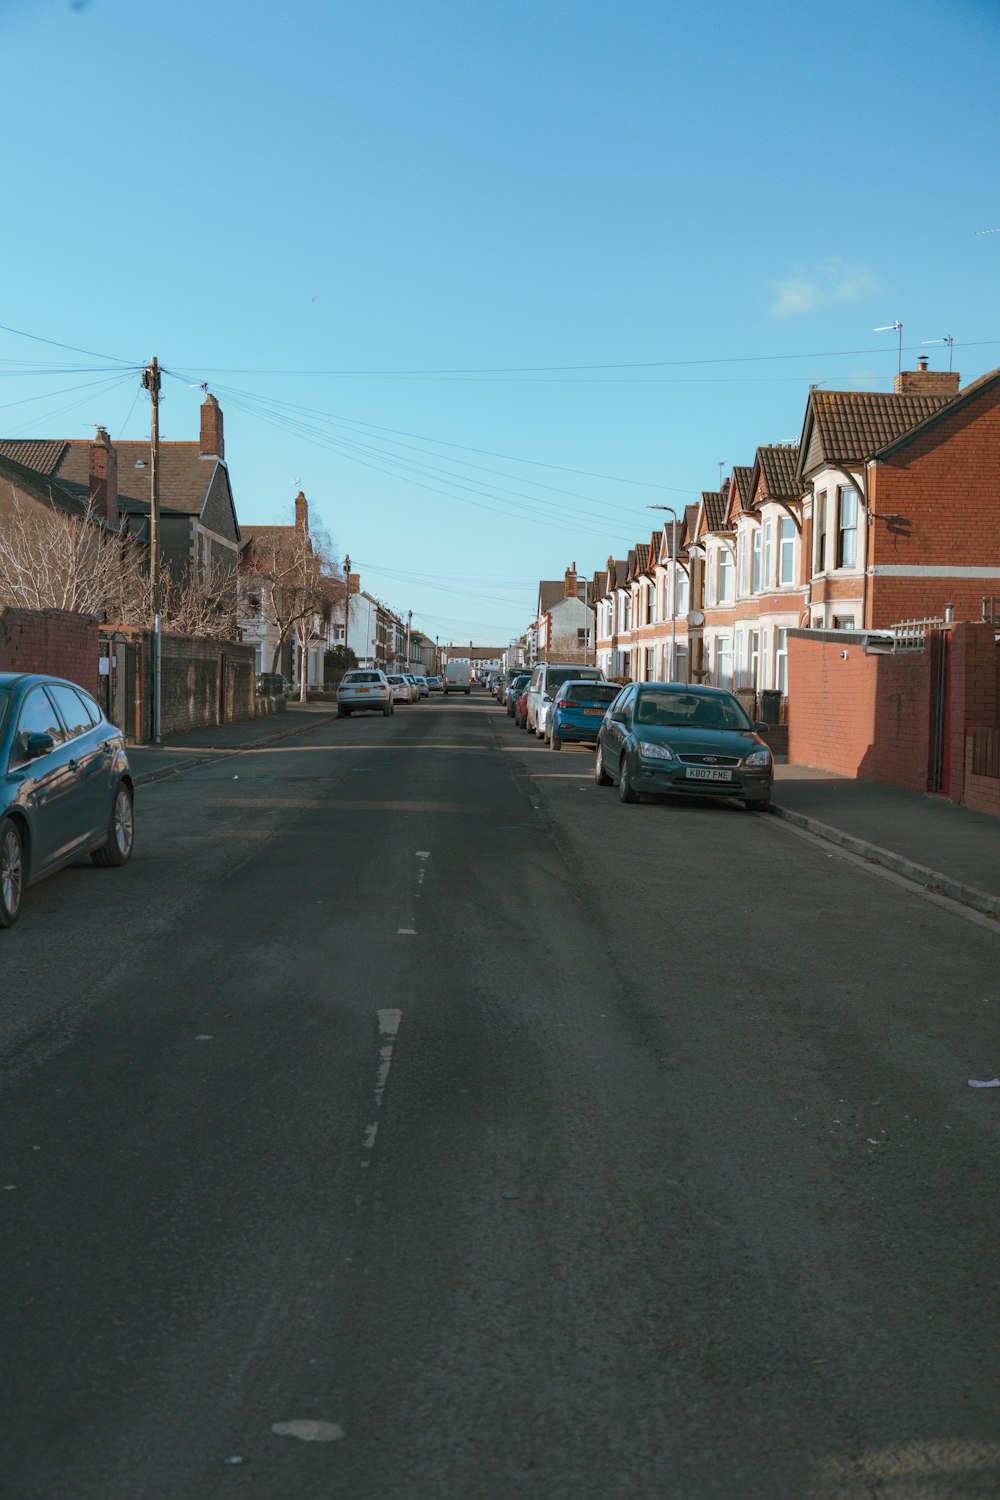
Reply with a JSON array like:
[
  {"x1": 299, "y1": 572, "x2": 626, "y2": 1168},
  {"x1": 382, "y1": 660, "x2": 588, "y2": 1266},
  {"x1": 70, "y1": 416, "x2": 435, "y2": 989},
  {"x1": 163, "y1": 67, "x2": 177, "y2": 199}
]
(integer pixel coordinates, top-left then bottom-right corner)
[{"x1": 0, "y1": 0, "x2": 1000, "y2": 644}]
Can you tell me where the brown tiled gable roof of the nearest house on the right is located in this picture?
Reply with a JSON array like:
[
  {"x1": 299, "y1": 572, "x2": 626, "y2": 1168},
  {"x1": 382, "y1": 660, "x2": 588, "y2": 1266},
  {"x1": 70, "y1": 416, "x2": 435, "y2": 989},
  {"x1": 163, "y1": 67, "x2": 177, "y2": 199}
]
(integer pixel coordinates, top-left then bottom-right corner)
[{"x1": 796, "y1": 390, "x2": 960, "y2": 489}]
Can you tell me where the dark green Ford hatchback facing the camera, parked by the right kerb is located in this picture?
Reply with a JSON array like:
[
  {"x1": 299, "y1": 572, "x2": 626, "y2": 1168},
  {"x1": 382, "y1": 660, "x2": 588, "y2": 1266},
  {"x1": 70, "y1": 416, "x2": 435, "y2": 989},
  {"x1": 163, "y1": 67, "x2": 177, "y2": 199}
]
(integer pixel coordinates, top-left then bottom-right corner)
[{"x1": 594, "y1": 683, "x2": 774, "y2": 812}]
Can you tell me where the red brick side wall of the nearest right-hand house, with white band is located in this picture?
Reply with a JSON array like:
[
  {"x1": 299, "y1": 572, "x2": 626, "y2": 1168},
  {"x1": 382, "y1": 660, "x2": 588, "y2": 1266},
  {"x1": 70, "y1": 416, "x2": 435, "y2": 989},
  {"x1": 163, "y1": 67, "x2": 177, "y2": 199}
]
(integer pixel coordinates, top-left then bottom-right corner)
[{"x1": 868, "y1": 384, "x2": 1000, "y2": 633}]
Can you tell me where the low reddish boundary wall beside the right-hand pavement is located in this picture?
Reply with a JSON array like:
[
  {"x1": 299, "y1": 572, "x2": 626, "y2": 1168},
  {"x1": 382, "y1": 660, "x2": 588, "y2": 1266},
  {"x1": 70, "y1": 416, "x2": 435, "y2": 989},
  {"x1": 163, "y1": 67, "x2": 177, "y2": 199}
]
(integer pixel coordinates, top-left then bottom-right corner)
[{"x1": 789, "y1": 624, "x2": 1000, "y2": 812}]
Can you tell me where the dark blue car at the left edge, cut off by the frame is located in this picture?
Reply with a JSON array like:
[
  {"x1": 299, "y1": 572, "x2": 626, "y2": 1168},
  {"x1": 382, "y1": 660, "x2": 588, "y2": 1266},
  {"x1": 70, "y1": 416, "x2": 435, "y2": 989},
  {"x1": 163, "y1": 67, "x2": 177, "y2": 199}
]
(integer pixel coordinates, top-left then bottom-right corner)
[{"x1": 0, "y1": 672, "x2": 135, "y2": 927}]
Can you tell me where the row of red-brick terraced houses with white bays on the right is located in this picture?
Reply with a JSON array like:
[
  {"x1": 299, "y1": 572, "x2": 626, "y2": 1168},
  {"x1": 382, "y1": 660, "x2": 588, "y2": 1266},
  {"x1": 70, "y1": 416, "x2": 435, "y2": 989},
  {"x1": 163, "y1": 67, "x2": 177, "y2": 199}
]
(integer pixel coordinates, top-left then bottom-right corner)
[{"x1": 592, "y1": 359, "x2": 1000, "y2": 696}]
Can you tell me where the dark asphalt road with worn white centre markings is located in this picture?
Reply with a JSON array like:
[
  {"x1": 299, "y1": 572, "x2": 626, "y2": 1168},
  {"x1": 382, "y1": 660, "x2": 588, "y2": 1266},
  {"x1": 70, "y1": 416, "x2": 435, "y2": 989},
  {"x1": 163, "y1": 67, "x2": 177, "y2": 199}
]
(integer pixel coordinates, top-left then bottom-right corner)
[{"x1": 0, "y1": 696, "x2": 1000, "y2": 1500}]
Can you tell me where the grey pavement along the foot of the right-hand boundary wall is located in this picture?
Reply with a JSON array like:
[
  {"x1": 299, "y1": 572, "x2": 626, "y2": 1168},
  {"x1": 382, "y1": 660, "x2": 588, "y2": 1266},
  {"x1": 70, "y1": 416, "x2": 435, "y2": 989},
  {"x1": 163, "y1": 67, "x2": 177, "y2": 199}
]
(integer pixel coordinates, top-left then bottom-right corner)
[{"x1": 771, "y1": 765, "x2": 1000, "y2": 917}]
